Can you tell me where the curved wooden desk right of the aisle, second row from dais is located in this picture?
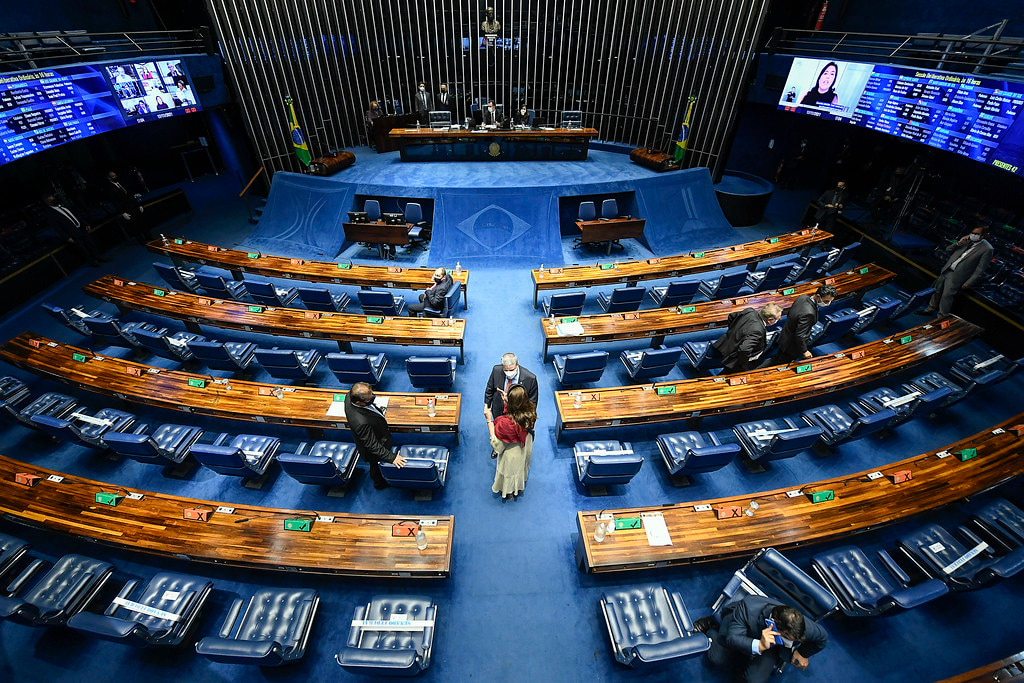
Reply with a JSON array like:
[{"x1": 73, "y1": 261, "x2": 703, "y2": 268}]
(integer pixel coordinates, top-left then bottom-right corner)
[{"x1": 541, "y1": 264, "x2": 896, "y2": 360}]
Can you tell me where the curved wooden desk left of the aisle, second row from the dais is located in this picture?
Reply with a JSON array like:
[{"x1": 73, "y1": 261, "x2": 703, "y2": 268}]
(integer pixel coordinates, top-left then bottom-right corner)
[{"x1": 82, "y1": 275, "x2": 466, "y2": 359}]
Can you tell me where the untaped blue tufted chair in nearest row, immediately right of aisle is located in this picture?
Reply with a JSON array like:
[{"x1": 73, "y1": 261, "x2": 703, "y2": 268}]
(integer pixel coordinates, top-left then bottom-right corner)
[{"x1": 598, "y1": 584, "x2": 711, "y2": 669}]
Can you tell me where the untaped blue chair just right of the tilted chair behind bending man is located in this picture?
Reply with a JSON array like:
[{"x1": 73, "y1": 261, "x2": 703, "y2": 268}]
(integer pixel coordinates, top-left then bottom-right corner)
[{"x1": 811, "y1": 546, "x2": 949, "y2": 616}]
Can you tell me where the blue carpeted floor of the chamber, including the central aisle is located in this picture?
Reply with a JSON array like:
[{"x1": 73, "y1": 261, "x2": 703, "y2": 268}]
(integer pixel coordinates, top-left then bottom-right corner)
[{"x1": 0, "y1": 161, "x2": 1024, "y2": 681}]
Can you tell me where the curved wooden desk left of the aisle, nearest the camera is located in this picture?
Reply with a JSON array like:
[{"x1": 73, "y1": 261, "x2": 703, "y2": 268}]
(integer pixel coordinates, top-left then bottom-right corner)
[{"x1": 0, "y1": 456, "x2": 455, "y2": 579}]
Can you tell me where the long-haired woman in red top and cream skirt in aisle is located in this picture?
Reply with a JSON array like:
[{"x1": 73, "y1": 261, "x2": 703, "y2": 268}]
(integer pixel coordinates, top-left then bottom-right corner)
[{"x1": 483, "y1": 384, "x2": 537, "y2": 502}]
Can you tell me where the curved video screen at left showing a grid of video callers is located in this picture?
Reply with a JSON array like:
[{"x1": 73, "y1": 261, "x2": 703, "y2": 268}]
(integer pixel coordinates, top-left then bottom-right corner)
[{"x1": 0, "y1": 59, "x2": 200, "y2": 165}]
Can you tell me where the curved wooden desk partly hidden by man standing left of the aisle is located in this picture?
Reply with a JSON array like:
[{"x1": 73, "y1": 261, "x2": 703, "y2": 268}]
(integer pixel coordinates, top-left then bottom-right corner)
[{"x1": 0, "y1": 332, "x2": 462, "y2": 442}]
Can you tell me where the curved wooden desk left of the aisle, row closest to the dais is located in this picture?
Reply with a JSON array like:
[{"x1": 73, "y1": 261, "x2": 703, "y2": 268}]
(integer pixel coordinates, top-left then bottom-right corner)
[{"x1": 146, "y1": 238, "x2": 469, "y2": 308}]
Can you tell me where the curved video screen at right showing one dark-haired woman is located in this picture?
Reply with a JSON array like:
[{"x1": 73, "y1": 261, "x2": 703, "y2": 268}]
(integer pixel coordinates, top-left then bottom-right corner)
[{"x1": 778, "y1": 57, "x2": 1024, "y2": 176}]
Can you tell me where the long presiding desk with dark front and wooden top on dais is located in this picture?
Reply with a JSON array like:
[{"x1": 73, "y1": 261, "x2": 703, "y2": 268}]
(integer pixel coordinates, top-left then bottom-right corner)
[{"x1": 390, "y1": 128, "x2": 598, "y2": 161}]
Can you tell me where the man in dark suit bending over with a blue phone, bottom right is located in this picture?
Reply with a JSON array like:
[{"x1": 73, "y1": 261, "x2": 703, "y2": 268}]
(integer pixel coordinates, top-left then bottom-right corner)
[{"x1": 694, "y1": 595, "x2": 828, "y2": 683}]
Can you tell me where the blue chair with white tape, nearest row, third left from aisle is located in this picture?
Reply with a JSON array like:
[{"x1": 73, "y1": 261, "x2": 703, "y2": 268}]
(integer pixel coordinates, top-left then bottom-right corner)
[{"x1": 68, "y1": 571, "x2": 213, "y2": 646}]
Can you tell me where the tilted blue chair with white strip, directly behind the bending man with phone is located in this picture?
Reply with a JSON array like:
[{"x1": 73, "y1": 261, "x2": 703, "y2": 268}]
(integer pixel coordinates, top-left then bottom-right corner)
[{"x1": 712, "y1": 548, "x2": 839, "y2": 622}]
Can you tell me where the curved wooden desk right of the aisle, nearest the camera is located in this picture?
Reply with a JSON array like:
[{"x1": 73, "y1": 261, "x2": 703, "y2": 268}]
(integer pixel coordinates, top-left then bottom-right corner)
[{"x1": 577, "y1": 413, "x2": 1024, "y2": 573}]
